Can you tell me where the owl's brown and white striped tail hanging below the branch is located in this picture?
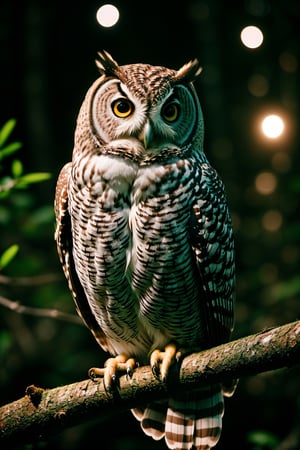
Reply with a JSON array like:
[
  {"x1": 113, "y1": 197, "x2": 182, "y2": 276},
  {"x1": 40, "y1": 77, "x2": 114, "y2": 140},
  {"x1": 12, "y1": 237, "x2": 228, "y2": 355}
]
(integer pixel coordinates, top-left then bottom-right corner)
[{"x1": 132, "y1": 385, "x2": 224, "y2": 450}]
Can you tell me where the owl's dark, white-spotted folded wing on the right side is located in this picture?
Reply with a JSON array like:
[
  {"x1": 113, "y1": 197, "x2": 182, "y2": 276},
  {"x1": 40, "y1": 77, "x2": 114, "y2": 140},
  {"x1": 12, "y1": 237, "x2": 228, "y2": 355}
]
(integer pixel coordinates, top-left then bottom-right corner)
[{"x1": 190, "y1": 164, "x2": 235, "y2": 347}]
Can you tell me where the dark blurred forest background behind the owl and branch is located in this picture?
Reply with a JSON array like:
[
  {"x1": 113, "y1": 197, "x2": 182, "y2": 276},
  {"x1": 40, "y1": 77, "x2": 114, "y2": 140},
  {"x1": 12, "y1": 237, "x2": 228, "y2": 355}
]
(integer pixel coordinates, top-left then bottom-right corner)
[{"x1": 0, "y1": 0, "x2": 300, "y2": 450}]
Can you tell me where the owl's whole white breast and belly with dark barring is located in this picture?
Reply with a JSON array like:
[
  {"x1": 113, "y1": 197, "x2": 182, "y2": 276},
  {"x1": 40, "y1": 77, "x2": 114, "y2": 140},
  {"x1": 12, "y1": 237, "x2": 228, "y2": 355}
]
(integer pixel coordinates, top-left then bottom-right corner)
[{"x1": 69, "y1": 156, "x2": 200, "y2": 353}]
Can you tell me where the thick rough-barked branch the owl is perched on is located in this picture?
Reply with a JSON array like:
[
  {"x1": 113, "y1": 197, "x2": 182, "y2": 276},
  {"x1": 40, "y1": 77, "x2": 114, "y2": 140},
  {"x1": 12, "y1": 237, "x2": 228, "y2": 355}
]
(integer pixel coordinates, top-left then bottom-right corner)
[{"x1": 0, "y1": 321, "x2": 300, "y2": 448}]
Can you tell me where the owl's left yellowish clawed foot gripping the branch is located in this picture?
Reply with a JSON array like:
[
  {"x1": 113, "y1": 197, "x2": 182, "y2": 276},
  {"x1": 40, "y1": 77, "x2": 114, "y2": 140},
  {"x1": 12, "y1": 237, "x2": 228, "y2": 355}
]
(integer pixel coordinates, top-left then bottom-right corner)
[{"x1": 88, "y1": 354, "x2": 138, "y2": 392}]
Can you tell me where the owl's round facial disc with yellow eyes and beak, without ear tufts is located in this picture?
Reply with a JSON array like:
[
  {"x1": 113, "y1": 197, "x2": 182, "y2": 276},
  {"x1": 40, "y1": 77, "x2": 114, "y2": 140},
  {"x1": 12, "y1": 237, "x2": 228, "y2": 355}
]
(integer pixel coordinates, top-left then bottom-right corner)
[{"x1": 91, "y1": 79, "x2": 201, "y2": 154}]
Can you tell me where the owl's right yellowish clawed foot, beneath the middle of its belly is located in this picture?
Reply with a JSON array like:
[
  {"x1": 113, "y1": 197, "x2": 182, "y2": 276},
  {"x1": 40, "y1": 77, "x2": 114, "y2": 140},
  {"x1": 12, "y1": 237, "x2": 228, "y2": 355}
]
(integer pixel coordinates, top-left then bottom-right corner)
[{"x1": 150, "y1": 343, "x2": 183, "y2": 382}]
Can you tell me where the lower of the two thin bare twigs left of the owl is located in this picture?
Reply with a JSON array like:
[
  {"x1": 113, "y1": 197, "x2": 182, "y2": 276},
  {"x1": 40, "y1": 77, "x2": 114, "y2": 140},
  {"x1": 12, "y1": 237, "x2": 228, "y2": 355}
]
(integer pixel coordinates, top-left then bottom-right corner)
[{"x1": 0, "y1": 296, "x2": 83, "y2": 325}]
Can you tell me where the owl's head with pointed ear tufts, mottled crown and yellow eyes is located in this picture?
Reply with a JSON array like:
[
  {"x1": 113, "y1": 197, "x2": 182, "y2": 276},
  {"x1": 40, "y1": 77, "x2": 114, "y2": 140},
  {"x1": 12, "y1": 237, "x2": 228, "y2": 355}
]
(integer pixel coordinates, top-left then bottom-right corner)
[{"x1": 82, "y1": 52, "x2": 203, "y2": 162}]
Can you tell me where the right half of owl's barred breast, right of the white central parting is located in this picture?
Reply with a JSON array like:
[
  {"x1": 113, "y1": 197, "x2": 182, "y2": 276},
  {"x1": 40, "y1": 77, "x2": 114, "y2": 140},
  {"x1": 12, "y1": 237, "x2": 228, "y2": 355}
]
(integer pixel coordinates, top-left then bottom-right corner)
[{"x1": 130, "y1": 160, "x2": 202, "y2": 345}]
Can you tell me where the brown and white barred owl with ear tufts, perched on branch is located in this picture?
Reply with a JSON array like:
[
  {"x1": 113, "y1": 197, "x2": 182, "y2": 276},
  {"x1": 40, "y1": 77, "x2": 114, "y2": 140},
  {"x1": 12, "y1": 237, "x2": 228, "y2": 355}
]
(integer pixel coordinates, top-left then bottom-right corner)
[{"x1": 55, "y1": 51, "x2": 235, "y2": 450}]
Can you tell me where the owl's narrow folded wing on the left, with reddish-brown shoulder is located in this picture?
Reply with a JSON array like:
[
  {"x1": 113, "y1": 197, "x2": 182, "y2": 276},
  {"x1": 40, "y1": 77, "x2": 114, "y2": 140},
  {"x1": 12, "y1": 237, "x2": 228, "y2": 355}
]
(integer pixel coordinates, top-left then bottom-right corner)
[{"x1": 55, "y1": 163, "x2": 106, "y2": 349}]
